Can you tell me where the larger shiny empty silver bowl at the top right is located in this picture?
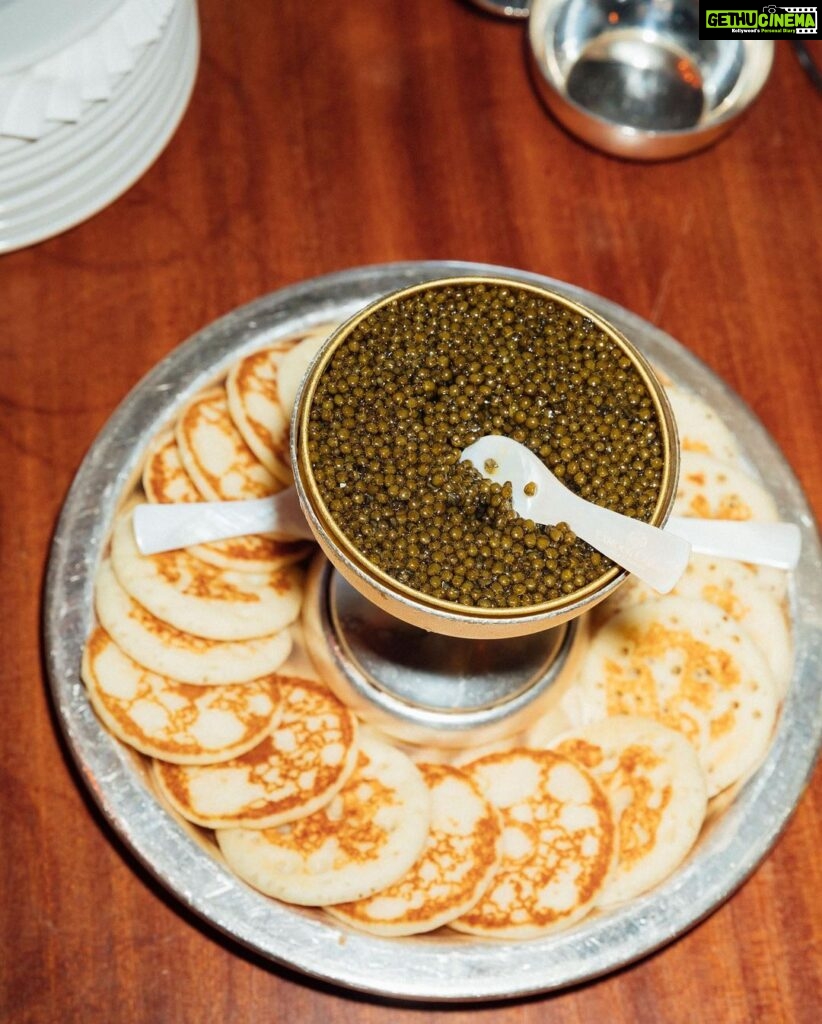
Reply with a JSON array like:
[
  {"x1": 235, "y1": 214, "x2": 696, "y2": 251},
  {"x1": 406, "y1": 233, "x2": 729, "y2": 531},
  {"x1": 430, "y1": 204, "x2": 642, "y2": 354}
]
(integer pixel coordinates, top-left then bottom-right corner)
[{"x1": 528, "y1": 0, "x2": 774, "y2": 160}]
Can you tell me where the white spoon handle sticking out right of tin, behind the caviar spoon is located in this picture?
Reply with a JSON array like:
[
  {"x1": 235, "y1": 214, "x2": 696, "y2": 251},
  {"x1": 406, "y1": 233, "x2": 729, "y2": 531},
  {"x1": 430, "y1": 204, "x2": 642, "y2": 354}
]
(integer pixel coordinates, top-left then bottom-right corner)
[{"x1": 665, "y1": 516, "x2": 802, "y2": 569}]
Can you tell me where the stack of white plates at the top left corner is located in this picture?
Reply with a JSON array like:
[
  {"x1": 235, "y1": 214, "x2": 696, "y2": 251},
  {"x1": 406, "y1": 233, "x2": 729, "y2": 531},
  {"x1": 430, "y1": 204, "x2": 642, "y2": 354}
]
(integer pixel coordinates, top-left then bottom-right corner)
[{"x1": 0, "y1": 0, "x2": 200, "y2": 253}]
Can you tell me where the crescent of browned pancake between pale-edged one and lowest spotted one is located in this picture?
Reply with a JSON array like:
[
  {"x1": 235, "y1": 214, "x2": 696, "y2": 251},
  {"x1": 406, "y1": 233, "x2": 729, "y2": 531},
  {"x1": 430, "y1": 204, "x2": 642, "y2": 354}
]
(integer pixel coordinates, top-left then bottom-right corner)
[{"x1": 328, "y1": 763, "x2": 502, "y2": 935}]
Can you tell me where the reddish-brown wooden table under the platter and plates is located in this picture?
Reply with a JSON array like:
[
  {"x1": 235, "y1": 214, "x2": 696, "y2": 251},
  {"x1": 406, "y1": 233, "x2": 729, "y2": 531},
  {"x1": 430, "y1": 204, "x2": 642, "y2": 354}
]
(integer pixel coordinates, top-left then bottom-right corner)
[{"x1": 0, "y1": 0, "x2": 822, "y2": 1024}]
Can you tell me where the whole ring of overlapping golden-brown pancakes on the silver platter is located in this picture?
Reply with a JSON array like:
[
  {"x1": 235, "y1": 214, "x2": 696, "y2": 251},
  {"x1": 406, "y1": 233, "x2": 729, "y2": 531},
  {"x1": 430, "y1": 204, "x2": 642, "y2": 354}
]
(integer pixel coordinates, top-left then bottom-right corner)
[{"x1": 83, "y1": 325, "x2": 790, "y2": 939}]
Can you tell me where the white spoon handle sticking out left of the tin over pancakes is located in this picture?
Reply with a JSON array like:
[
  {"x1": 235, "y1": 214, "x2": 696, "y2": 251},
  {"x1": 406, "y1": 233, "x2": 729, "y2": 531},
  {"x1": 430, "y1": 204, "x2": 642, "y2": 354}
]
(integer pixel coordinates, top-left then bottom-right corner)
[{"x1": 134, "y1": 487, "x2": 313, "y2": 555}]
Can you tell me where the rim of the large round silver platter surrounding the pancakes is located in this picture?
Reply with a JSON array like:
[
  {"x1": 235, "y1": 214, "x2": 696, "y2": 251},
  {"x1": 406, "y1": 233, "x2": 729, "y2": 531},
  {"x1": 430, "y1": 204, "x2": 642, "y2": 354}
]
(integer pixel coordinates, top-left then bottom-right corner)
[{"x1": 44, "y1": 261, "x2": 822, "y2": 1001}]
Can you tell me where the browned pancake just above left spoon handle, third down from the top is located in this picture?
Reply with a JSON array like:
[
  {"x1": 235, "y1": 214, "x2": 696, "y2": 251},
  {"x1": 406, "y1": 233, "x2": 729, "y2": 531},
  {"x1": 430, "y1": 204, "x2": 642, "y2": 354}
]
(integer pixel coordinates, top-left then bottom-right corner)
[{"x1": 174, "y1": 387, "x2": 283, "y2": 501}]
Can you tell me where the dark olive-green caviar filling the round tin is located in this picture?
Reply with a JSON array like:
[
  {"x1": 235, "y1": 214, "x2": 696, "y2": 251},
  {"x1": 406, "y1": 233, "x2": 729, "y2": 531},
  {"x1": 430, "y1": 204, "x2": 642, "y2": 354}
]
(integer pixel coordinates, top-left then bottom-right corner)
[{"x1": 308, "y1": 283, "x2": 663, "y2": 608}]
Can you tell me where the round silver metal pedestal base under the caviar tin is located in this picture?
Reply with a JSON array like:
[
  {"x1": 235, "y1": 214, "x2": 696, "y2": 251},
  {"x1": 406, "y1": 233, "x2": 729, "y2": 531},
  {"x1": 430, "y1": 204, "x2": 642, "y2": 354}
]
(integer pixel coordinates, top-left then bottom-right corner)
[{"x1": 303, "y1": 557, "x2": 582, "y2": 749}]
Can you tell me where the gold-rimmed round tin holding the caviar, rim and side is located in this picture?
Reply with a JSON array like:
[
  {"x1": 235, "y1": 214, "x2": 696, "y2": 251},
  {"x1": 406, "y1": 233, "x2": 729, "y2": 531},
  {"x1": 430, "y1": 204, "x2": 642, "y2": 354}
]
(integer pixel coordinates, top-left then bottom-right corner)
[{"x1": 292, "y1": 276, "x2": 679, "y2": 639}]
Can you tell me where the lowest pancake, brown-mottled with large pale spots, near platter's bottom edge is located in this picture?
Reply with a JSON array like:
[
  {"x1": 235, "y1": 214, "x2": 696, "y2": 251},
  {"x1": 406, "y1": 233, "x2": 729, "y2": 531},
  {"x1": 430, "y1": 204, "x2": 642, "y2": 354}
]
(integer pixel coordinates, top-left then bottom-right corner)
[{"x1": 450, "y1": 749, "x2": 616, "y2": 939}]
